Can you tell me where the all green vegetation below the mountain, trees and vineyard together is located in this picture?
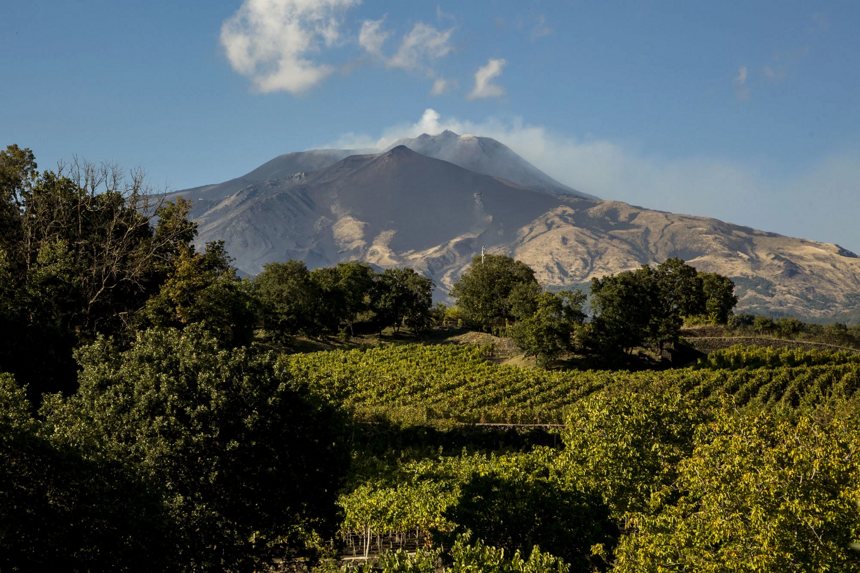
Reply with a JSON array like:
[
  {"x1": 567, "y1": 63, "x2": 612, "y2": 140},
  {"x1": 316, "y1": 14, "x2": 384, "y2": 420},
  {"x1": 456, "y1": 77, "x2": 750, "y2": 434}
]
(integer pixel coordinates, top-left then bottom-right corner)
[{"x1": 5, "y1": 146, "x2": 860, "y2": 573}]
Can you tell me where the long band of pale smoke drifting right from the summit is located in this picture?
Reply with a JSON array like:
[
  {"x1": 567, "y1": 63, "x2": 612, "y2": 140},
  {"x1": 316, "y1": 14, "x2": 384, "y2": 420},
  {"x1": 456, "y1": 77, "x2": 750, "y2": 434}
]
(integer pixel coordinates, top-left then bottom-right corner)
[{"x1": 320, "y1": 109, "x2": 860, "y2": 251}]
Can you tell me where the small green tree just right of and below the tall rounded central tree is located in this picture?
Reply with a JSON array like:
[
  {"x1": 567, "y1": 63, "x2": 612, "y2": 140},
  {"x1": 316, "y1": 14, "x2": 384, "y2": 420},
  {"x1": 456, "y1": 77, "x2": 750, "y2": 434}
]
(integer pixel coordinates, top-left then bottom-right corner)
[{"x1": 510, "y1": 291, "x2": 586, "y2": 367}]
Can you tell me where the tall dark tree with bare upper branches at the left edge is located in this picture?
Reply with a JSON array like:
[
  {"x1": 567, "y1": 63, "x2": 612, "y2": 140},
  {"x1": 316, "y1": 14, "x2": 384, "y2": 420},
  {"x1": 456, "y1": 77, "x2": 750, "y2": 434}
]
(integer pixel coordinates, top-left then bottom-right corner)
[{"x1": 0, "y1": 145, "x2": 194, "y2": 404}]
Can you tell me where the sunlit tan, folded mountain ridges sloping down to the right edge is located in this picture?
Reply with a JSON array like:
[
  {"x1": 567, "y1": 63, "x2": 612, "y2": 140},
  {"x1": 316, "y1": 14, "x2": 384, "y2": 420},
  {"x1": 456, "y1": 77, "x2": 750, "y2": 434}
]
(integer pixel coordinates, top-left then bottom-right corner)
[{"x1": 503, "y1": 201, "x2": 860, "y2": 317}]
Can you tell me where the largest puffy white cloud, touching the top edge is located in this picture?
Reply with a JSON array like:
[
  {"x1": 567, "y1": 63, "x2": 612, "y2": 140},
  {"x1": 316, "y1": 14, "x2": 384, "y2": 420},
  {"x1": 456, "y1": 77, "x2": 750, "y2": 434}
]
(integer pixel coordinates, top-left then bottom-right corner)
[{"x1": 221, "y1": 0, "x2": 360, "y2": 94}]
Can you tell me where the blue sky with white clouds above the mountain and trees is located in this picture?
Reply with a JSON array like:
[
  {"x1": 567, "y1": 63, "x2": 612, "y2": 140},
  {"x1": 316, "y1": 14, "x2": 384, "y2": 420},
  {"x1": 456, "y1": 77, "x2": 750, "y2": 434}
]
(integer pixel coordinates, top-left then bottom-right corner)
[{"x1": 0, "y1": 0, "x2": 860, "y2": 251}]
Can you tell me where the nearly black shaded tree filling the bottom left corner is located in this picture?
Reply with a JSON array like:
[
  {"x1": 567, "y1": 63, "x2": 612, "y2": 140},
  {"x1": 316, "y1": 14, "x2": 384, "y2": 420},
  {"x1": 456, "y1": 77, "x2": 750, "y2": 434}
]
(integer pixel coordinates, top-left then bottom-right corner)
[{"x1": 0, "y1": 374, "x2": 177, "y2": 571}]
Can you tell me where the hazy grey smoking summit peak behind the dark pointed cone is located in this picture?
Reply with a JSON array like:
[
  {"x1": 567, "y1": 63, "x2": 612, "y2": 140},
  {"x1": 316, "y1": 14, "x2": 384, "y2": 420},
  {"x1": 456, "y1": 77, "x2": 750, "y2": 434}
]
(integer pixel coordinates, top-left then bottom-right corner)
[{"x1": 389, "y1": 130, "x2": 597, "y2": 199}]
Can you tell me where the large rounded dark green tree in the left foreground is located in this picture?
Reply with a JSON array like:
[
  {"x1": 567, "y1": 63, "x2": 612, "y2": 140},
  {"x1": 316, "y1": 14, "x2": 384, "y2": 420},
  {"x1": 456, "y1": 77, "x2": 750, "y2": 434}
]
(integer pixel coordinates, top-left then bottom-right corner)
[{"x1": 44, "y1": 326, "x2": 348, "y2": 571}]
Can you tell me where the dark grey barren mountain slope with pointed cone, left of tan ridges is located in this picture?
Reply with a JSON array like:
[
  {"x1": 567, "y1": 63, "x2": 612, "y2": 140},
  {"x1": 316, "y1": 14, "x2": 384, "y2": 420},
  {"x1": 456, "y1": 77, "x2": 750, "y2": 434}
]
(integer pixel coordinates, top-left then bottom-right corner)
[{"x1": 179, "y1": 147, "x2": 558, "y2": 274}]
